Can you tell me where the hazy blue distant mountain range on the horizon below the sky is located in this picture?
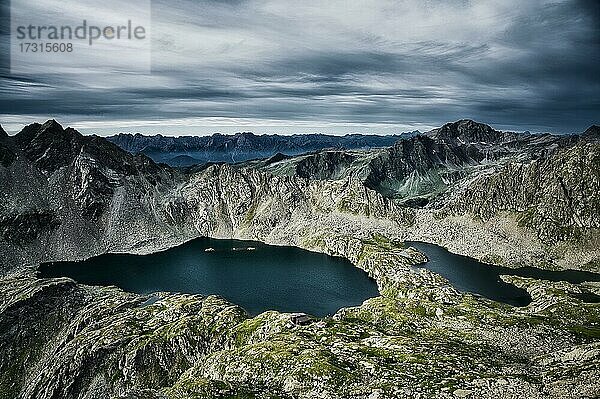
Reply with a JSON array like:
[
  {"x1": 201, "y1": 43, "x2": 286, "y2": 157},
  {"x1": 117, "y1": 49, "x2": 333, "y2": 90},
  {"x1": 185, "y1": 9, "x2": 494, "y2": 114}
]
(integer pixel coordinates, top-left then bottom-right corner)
[{"x1": 107, "y1": 131, "x2": 419, "y2": 166}]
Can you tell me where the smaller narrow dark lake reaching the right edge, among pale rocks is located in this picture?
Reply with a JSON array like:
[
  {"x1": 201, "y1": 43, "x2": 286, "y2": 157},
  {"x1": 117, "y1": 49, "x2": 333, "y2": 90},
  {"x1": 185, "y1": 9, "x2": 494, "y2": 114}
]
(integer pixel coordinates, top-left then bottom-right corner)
[{"x1": 406, "y1": 241, "x2": 600, "y2": 306}]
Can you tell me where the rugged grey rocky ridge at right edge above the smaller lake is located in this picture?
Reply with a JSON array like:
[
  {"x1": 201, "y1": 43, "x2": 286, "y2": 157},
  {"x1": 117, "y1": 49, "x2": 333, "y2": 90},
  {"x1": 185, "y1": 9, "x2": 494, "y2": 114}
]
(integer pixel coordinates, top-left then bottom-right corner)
[{"x1": 448, "y1": 142, "x2": 600, "y2": 243}]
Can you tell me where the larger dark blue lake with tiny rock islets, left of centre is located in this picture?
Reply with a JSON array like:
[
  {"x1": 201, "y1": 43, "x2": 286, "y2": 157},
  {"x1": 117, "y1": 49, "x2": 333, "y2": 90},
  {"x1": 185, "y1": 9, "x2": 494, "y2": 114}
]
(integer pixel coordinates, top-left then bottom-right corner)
[{"x1": 39, "y1": 238, "x2": 379, "y2": 316}]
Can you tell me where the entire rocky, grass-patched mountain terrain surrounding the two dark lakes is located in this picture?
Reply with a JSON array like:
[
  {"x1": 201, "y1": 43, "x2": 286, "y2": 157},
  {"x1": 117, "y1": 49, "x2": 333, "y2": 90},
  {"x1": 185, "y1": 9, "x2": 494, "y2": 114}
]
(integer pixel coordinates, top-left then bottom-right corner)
[{"x1": 0, "y1": 120, "x2": 600, "y2": 398}]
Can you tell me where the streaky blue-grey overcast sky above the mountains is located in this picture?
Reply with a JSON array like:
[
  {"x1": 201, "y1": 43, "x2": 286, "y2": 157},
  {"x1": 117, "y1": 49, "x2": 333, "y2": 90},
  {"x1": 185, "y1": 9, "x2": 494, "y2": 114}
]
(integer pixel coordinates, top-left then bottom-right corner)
[{"x1": 0, "y1": 0, "x2": 600, "y2": 135}]
